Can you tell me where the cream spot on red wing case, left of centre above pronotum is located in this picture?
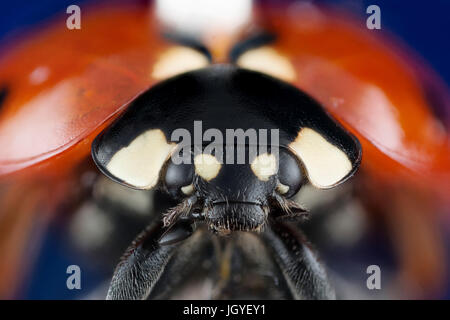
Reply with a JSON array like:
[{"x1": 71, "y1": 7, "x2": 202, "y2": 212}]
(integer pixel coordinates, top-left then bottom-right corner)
[{"x1": 152, "y1": 46, "x2": 209, "y2": 79}]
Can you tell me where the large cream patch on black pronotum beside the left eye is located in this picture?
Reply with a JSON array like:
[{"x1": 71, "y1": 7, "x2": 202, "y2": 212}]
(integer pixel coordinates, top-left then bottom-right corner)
[{"x1": 106, "y1": 129, "x2": 176, "y2": 189}]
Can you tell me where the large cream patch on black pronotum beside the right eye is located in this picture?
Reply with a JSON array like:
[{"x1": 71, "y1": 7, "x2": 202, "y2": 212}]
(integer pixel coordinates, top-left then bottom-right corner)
[{"x1": 289, "y1": 128, "x2": 352, "y2": 189}]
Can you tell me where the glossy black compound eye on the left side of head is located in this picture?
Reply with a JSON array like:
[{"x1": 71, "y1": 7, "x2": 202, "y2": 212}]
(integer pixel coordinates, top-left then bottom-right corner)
[{"x1": 164, "y1": 160, "x2": 194, "y2": 198}]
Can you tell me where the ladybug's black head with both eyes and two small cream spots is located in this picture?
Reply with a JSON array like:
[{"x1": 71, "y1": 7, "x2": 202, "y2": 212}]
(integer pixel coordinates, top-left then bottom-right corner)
[{"x1": 162, "y1": 144, "x2": 306, "y2": 234}]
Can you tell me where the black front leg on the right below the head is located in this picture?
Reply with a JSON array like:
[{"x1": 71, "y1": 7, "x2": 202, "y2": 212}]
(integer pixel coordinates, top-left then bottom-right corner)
[{"x1": 262, "y1": 221, "x2": 335, "y2": 299}]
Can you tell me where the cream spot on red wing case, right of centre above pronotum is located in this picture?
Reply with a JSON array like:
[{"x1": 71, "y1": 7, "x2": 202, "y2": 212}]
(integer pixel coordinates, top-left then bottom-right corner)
[{"x1": 237, "y1": 47, "x2": 296, "y2": 81}]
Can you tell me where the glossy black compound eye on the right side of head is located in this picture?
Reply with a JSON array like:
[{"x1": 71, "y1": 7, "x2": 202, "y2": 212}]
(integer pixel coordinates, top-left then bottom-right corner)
[{"x1": 277, "y1": 149, "x2": 304, "y2": 198}]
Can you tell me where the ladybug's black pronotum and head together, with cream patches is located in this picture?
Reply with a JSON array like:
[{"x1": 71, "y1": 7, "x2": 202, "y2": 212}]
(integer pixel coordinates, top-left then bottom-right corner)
[{"x1": 92, "y1": 65, "x2": 361, "y2": 233}]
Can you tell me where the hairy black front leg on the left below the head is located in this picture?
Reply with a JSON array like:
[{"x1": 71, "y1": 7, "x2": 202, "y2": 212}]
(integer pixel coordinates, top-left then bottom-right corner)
[{"x1": 106, "y1": 221, "x2": 196, "y2": 300}]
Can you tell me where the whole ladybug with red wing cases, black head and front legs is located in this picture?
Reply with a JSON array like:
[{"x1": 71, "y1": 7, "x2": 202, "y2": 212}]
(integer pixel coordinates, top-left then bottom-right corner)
[{"x1": 0, "y1": 3, "x2": 450, "y2": 299}]
